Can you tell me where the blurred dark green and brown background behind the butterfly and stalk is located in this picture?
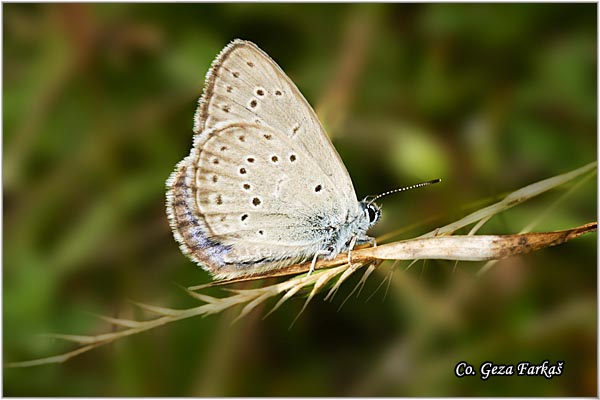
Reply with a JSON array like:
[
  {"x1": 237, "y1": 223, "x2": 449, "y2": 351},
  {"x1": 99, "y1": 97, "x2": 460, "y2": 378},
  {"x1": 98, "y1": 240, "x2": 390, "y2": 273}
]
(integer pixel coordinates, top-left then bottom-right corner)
[{"x1": 2, "y1": 4, "x2": 597, "y2": 396}]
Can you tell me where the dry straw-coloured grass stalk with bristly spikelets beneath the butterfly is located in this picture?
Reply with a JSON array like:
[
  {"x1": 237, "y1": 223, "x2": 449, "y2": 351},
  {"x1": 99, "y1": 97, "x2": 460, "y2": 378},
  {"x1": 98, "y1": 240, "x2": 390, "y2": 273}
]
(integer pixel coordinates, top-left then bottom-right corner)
[{"x1": 7, "y1": 163, "x2": 597, "y2": 367}]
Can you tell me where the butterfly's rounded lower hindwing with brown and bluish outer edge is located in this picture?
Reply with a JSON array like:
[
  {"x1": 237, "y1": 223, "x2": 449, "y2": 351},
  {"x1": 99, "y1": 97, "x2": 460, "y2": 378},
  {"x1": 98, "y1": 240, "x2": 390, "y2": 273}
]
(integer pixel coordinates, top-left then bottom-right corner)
[{"x1": 169, "y1": 123, "x2": 348, "y2": 278}]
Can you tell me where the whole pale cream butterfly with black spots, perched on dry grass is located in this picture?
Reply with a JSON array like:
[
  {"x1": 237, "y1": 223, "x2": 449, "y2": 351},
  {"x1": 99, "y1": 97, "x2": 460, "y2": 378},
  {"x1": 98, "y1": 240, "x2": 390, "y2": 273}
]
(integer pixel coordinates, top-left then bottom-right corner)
[{"x1": 167, "y1": 40, "x2": 380, "y2": 278}]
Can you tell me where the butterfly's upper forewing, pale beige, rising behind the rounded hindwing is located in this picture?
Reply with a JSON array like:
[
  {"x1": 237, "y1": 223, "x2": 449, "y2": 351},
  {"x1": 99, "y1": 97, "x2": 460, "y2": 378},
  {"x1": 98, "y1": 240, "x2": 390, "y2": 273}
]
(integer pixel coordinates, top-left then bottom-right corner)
[{"x1": 194, "y1": 40, "x2": 357, "y2": 206}]
